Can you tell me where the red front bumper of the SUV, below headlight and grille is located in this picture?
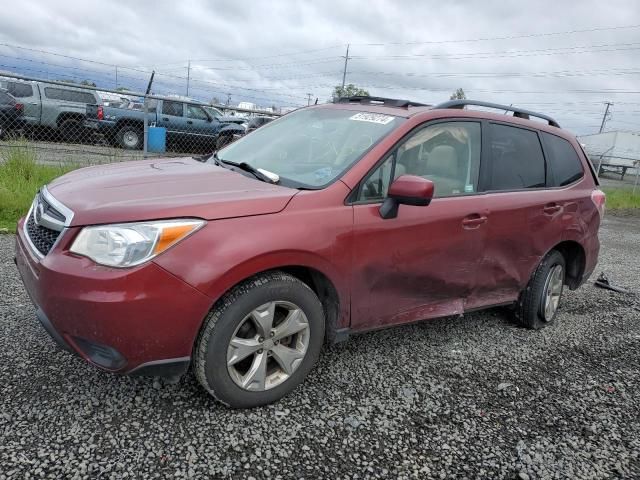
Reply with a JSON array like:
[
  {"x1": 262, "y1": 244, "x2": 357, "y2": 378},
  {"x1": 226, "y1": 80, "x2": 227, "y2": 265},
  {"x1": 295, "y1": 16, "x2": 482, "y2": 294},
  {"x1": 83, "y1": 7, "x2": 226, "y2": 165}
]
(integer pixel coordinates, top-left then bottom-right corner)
[{"x1": 16, "y1": 220, "x2": 212, "y2": 376}]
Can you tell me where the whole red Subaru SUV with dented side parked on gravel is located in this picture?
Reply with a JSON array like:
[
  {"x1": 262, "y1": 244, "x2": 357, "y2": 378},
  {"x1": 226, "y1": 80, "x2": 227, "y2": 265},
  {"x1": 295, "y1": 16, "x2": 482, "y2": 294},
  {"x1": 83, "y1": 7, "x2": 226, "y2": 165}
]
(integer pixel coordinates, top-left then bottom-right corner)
[{"x1": 16, "y1": 97, "x2": 605, "y2": 407}]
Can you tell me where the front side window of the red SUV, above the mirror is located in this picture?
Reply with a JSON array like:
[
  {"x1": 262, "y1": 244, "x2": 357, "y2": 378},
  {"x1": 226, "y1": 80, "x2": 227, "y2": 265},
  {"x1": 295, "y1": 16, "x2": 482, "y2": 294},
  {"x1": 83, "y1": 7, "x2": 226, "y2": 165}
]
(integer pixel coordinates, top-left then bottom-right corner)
[{"x1": 359, "y1": 122, "x2": 481, "y2": 201}]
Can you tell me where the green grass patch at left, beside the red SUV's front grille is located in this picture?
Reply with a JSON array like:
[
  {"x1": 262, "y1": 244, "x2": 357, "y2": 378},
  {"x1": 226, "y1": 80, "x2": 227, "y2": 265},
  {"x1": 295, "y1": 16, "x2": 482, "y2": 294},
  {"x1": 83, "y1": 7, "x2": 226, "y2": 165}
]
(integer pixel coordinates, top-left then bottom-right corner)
[{"x1": 0, "y1": 140, "x2": 77, "y2": 233}]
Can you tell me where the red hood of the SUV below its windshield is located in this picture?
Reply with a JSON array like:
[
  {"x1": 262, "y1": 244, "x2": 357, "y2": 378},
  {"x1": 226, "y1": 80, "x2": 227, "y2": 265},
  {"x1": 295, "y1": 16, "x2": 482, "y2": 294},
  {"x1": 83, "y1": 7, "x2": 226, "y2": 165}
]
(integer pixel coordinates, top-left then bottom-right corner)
[{"x1": 47, "y1": 158, "x2": 298, "y2": 226}]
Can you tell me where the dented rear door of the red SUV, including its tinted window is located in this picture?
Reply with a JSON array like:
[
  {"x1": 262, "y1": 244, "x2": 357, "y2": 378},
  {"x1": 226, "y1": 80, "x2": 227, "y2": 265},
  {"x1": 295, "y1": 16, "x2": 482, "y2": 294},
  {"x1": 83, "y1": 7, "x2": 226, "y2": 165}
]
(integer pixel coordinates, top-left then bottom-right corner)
[{"x1": 470, "y1": 122, "x2": 559, "y2": 308}]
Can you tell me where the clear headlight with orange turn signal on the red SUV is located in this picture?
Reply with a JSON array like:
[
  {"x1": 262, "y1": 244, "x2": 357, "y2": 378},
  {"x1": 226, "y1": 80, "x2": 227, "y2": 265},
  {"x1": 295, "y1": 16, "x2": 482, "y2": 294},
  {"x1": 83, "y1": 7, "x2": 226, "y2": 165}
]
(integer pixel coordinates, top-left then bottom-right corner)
[{"x1": 71, "y1": 219, "x2": 205, "y2": 267}]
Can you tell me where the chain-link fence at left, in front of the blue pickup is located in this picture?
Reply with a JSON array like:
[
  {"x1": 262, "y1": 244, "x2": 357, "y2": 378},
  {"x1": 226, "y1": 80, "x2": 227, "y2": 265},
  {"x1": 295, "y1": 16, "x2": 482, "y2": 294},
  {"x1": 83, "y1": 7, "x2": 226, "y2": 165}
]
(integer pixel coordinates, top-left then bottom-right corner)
[{"x1": 0, "y1": 74, "x2": 279, "y2": 166}]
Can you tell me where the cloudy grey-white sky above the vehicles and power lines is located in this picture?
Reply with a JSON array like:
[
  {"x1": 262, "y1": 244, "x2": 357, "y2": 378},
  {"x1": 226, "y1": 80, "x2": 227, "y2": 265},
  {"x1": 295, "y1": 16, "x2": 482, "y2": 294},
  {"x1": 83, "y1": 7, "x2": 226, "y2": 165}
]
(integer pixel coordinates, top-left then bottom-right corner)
[{"x1": 0, "y1": 0, "x2": 640, "y2": 134}]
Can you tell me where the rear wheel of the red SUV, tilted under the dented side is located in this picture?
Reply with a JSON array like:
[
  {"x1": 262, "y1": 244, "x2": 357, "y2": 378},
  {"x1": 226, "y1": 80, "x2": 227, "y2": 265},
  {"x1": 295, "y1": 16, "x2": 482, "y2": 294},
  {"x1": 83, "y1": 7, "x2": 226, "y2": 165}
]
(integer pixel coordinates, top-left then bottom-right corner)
[{"x1": 515, "y1": 250, "x2": 566, "y2": 330}]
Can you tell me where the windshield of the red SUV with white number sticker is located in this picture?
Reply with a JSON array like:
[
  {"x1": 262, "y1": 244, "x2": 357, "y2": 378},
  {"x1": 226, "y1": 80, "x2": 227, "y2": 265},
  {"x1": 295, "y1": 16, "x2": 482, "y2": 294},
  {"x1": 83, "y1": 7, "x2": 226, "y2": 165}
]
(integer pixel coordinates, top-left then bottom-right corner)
[{"x1": 218, "y1": 108, "x2": 403, "y2": 188}]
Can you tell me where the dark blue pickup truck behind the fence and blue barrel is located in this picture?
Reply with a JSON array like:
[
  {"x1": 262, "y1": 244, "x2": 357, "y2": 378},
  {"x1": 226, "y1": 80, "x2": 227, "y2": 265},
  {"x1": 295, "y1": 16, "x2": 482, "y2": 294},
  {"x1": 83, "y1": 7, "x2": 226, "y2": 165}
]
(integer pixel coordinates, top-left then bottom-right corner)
[{"x1": 86, "y1": 98, "x2": 249, "y2": 150}]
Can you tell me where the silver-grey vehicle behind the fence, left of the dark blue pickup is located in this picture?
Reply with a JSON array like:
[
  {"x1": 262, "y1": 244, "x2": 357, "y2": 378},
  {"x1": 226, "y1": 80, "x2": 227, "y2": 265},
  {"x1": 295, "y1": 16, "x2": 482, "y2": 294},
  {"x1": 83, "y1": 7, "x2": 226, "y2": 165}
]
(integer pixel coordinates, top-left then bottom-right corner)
[{"x1": 0, "y1": 77, "x2": 101, "y2": 142}]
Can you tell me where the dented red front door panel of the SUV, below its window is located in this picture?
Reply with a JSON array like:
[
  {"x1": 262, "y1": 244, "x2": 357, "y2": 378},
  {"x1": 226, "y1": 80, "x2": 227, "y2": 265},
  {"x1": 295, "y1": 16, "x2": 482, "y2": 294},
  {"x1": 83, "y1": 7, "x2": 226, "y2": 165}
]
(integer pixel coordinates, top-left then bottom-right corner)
[{"x1": 351, "y1": 196, "x2": 486, "y2": 330}]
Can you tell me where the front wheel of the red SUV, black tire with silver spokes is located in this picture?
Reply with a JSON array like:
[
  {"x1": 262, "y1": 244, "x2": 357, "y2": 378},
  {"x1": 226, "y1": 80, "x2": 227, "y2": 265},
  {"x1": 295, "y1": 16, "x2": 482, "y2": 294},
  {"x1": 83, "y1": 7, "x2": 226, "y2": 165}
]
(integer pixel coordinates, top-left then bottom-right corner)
[{"x1": 193, "y1": 271, "x2": 325, "y2": 408}]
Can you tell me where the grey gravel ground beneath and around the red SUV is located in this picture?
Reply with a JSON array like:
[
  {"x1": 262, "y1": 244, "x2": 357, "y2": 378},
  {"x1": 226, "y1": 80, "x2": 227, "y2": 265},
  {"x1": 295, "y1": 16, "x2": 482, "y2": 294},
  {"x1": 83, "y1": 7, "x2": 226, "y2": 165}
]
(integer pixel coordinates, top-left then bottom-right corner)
[{"x1": 0, "y1": 215, "x2": 640, "y2": 479}]
